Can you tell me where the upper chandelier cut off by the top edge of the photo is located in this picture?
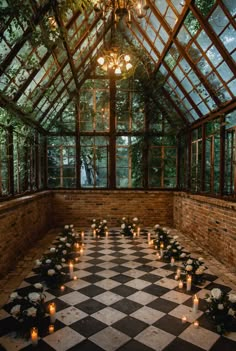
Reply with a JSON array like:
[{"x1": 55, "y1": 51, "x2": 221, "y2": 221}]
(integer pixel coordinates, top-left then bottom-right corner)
[{"x1": 93, "y1": 0, "x2": 149, "y2": 25}]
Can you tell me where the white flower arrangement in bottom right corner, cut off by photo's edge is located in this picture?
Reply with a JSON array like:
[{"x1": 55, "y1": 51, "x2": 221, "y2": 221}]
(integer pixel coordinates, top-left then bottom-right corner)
[{"x1": 205, "y1": 288, "x2": 236, "y2": 334}]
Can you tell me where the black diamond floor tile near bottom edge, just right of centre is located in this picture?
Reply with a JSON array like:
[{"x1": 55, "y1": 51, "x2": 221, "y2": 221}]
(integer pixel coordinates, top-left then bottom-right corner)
[{"x1": 112, "y1": 316, "x2": 148, "y2": 338}]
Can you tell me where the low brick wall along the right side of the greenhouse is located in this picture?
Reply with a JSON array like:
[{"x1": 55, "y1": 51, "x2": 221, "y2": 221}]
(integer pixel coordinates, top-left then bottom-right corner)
[{"x1": 173, "y1": 192, "x2": 236, "y2": 267}]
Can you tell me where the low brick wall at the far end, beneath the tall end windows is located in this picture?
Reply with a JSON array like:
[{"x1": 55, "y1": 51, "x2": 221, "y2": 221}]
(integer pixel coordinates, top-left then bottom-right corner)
[{"x1": 53, "y1": 190, "x2": 173, "y2": 227}]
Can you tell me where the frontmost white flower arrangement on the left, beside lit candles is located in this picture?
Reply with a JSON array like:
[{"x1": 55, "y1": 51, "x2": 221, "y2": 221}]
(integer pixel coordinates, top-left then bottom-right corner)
[{"x1": 4, "y1": 283, "x2": 46, "y2": 337}]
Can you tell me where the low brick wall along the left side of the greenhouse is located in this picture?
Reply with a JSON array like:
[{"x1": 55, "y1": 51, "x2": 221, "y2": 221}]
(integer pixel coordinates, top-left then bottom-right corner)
[{"x1": 0, "y1": 192, "x2": 52, "y2": 276}]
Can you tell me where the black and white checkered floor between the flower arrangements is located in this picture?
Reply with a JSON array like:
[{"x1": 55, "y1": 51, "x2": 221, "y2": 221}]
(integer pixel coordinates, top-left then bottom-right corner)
[{"x1": 0, "y1": 230, "x2": 236, "y2": 351}]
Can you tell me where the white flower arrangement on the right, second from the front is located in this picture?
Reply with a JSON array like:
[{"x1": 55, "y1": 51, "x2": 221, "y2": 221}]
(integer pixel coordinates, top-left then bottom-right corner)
[{"x1": 182, "y1": 256, "x2": 207, "y2": 285}]
